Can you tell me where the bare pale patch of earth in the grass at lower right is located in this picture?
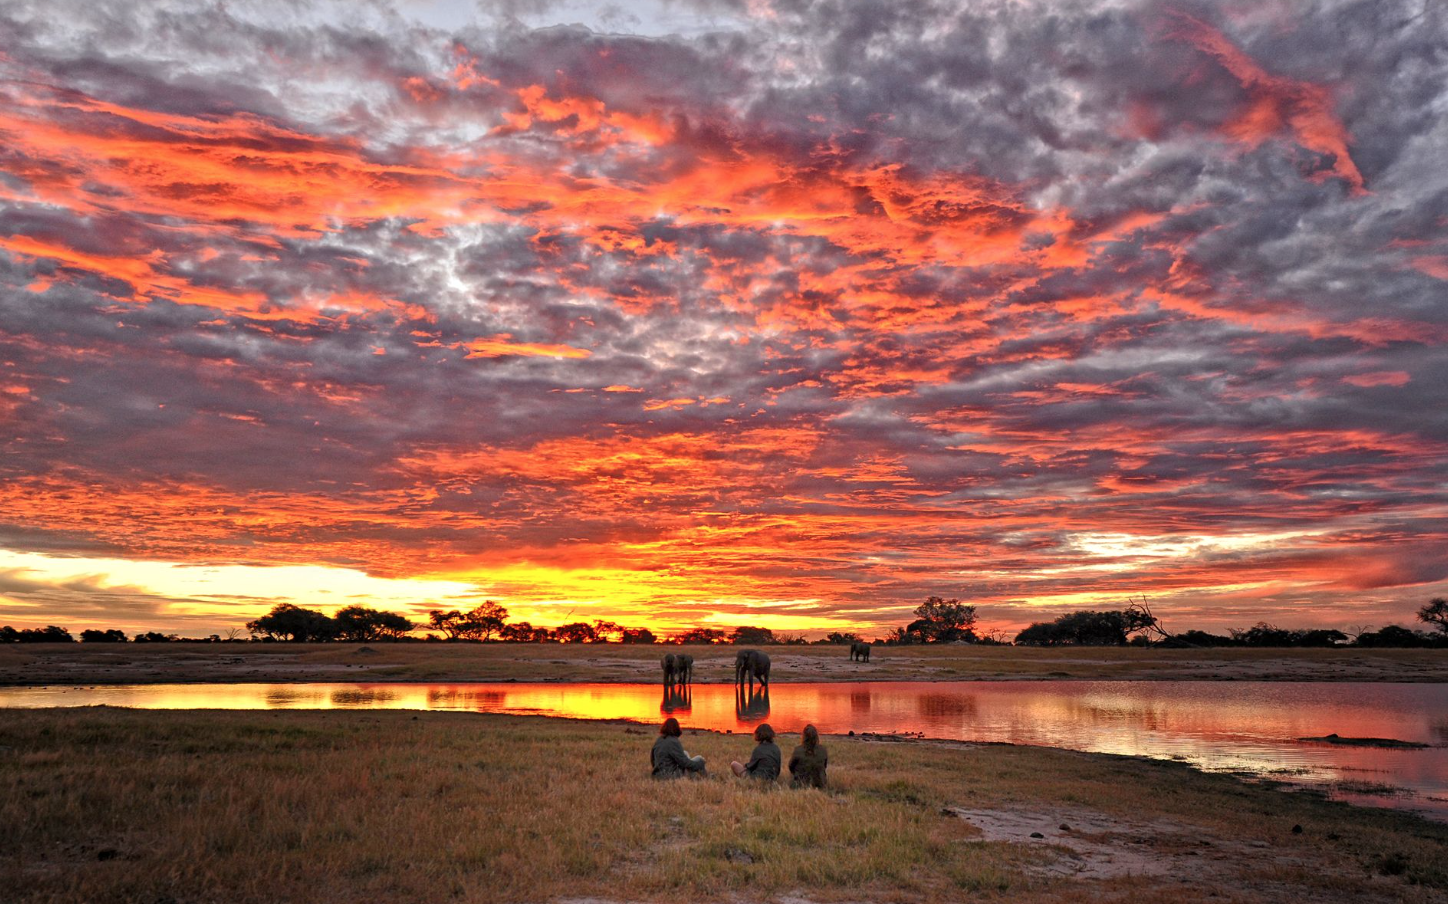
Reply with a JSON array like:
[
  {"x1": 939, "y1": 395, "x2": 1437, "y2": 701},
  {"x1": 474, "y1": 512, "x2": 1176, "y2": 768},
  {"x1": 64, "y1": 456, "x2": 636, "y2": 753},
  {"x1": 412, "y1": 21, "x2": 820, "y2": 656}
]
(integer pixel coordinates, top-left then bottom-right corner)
[{"x1": 944, "y1": 807, "x2": 1295, "y2": 879}]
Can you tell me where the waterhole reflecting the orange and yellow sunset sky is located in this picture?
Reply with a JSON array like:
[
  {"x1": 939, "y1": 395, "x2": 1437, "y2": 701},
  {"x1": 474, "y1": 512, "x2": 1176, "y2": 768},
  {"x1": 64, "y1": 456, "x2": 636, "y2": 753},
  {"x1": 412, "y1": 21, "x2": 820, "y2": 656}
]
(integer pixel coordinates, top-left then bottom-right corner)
[{"x1": 0, "y1": 681, "x2": 1448, "y2": 819}]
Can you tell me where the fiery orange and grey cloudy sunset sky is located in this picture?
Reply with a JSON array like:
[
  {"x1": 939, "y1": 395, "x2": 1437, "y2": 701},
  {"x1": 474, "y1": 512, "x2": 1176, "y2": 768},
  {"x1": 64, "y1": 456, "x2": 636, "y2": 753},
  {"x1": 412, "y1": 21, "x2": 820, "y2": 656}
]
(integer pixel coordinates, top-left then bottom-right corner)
[{"x1": 0, "y1": 0, "x2": 1448, "y2": 636}]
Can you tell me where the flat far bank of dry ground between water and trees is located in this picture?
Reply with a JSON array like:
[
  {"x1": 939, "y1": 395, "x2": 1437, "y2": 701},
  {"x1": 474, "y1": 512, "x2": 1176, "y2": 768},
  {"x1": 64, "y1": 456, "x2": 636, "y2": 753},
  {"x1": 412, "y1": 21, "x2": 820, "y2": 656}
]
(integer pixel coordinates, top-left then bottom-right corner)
[{"x1": 0, "y1": 643, "x2": 1448, "y2": 685}]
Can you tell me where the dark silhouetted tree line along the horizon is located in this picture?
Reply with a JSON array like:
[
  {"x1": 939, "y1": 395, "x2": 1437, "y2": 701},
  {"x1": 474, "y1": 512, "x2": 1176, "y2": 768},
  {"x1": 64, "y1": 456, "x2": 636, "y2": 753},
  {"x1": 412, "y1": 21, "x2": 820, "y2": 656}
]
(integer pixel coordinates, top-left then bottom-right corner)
[{"x1": 0, "y1": 597, "x2": 1448, "y2": 648}]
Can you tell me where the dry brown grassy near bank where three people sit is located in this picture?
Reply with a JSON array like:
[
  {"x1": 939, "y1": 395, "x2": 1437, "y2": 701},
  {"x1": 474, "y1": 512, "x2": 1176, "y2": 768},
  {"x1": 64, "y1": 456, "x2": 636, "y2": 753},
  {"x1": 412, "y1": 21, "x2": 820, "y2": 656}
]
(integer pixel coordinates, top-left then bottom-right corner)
[{"x1": 0, "y1": 708, "x2": 1448, "y2": 904}]
